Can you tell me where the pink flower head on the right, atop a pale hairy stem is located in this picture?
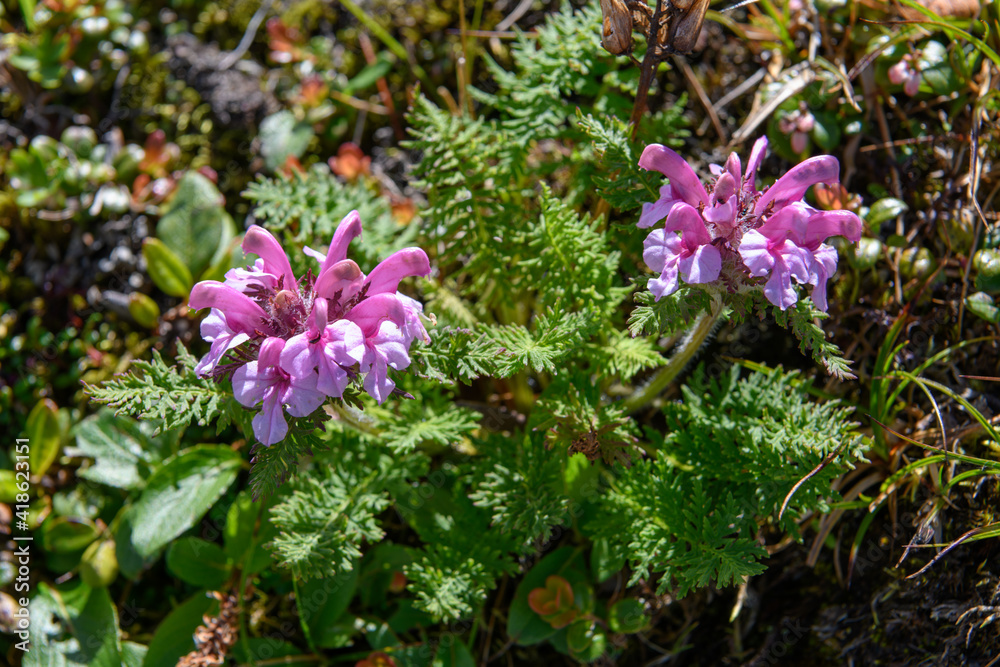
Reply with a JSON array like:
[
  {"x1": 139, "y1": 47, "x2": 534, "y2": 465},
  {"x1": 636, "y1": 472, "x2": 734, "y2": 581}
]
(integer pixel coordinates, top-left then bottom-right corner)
[{"x1": 639, "y1": 138, "x2": 861, "y2": 311}]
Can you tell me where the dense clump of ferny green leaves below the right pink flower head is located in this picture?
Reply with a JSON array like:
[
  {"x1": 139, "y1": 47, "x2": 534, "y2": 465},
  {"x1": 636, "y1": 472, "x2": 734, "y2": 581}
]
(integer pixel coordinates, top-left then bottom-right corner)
[{"x1": 587, "y1": 367, "x2": 863, "y2": 595}]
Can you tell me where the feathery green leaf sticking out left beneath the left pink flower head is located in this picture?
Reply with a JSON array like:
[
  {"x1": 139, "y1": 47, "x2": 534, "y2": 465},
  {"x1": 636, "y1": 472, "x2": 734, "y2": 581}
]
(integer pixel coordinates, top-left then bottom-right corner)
[{"x1": 87, "y1": 341, "x2": 232, "y2": 433}]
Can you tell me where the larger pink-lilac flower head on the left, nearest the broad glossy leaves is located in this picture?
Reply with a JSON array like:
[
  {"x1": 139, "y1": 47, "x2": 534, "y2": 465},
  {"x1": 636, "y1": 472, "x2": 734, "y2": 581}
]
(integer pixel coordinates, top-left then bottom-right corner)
[{"x1": 189, "y1": 211, "x2": 430, "y2": 446}]
